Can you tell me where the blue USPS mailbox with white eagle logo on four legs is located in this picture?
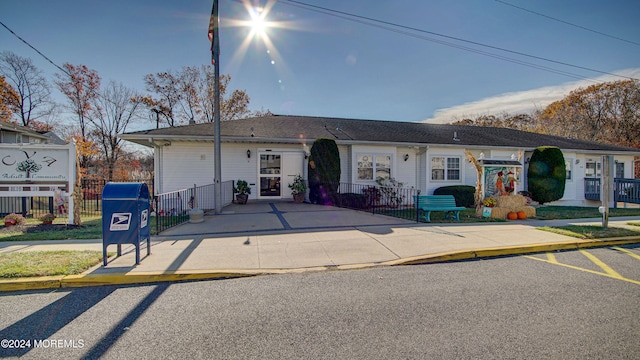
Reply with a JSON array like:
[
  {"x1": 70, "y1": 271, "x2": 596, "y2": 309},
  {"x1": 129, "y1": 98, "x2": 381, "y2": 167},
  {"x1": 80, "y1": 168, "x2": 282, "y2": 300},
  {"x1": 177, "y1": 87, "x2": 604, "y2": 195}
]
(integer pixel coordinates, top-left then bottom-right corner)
[{"x1": 102, "y1": 182, "x2": 151, "y2": 266}]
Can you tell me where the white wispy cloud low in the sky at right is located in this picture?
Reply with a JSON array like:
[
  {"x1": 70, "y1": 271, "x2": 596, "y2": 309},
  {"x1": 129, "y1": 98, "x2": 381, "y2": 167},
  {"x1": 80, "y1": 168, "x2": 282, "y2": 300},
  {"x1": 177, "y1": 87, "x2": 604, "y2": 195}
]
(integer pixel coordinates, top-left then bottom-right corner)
[{"x1": 423, "y1": 68, "x2": 640, "y2": 124}]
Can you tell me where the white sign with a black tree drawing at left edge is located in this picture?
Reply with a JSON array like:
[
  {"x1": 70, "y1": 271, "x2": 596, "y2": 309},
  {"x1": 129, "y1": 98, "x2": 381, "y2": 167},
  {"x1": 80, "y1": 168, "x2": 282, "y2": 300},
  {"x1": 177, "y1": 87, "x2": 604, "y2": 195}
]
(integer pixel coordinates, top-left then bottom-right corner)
[{"x1": 0, "y1": 144, "x2": 69, "y2": 183}]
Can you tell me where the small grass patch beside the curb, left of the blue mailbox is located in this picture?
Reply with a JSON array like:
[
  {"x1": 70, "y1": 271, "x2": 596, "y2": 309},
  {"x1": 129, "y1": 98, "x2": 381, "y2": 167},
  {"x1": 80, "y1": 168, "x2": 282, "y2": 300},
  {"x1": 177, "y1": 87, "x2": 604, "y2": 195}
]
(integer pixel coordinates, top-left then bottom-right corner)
[{"x1": 0, "y1": 251, "x2": 102, "y2": 279}]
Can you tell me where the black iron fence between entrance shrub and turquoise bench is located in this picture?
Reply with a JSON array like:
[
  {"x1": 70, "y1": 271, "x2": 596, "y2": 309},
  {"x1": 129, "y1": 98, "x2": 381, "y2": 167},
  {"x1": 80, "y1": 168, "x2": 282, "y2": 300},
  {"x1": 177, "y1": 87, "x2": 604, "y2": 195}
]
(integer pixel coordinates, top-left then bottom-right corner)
[{"x1": 310, "y1": 183, "x2": 420, "y2": 221}]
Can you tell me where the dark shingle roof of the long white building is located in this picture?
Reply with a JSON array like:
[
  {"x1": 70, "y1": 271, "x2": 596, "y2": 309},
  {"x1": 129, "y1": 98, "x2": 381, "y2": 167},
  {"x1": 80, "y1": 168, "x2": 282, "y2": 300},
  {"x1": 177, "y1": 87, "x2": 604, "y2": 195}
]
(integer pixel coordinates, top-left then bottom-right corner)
[{"x1": 122, "y1": 115, "x2": 640, "y2": 153}]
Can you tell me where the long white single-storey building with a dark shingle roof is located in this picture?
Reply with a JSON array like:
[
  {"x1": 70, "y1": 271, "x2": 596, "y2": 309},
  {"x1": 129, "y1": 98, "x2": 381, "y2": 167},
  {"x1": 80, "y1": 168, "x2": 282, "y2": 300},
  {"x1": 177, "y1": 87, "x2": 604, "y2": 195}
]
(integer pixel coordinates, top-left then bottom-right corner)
[{"x1": 120, "y1": 115, "x2": 640, "y2": 206}]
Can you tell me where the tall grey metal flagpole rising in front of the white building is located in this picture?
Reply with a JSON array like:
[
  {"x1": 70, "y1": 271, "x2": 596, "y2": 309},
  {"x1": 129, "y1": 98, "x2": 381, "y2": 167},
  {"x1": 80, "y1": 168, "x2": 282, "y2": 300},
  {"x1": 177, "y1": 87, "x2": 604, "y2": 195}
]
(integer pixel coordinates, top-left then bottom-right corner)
[{"x1": 209, "y1": 0, "x2": 222, "y2": 214}]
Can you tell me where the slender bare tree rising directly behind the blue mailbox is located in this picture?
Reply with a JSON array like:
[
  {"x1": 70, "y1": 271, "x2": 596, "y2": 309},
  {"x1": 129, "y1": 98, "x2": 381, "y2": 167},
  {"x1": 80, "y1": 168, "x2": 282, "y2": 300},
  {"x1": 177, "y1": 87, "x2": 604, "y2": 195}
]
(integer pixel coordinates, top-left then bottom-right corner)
[{"x1": 89, "y1": 81, "x2": 141, "y2": 181}]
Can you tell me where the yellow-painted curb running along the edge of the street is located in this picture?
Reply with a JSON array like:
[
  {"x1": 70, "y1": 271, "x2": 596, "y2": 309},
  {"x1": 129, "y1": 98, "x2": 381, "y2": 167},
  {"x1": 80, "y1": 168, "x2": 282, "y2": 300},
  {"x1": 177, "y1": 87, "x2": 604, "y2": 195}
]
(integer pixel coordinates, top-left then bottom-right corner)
[{"x1": 0, "y1": 236, "x2": 640, "y2": 292}]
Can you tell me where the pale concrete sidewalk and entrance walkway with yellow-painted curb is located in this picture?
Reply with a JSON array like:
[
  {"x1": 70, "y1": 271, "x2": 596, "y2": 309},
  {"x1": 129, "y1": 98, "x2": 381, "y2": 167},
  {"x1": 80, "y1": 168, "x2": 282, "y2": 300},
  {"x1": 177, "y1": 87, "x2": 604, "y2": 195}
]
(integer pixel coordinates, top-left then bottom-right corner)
[{"x1": 0, "y1": 202, "x2": 640, "y2": 291}]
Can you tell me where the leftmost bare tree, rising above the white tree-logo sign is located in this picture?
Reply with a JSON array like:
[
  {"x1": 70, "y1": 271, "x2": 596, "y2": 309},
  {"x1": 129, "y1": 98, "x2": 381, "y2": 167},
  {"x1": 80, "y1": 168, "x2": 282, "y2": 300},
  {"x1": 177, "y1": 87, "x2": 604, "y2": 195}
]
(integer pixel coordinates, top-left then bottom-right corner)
[{"x1": 0, "y1": 51, "x2": 54, "y2": 126}]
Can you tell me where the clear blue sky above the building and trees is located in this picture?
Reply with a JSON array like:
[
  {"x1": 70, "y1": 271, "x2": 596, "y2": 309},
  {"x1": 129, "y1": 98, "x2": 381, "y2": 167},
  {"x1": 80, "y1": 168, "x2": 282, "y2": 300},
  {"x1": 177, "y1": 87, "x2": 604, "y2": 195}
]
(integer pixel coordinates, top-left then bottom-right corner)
[{"x1": 0, "y1": 0, "x2": 640, "y2": 127}]
